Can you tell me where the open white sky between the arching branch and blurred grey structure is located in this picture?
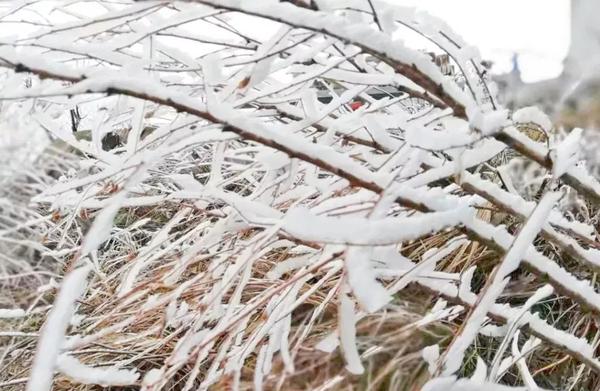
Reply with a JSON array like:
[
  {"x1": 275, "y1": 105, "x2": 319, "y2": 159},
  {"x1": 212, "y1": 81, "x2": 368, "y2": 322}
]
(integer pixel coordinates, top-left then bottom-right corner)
[{"x1": 396, "y1": 0, "x2": 568, "y2": 82}]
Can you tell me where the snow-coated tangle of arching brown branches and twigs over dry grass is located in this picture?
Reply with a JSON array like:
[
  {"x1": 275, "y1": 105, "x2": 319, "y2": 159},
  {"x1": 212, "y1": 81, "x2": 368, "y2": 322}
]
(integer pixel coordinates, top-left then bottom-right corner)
[{"x1": 0, "y1": 0, "x2": 600, "y2": 391}]
